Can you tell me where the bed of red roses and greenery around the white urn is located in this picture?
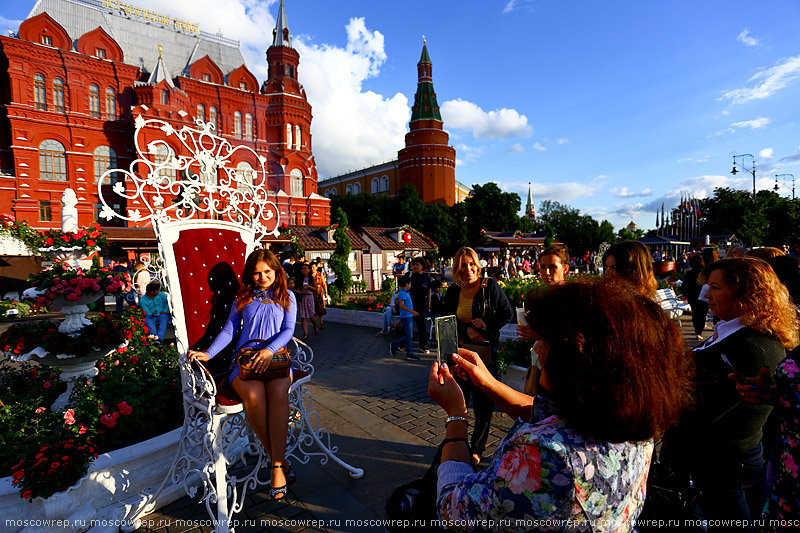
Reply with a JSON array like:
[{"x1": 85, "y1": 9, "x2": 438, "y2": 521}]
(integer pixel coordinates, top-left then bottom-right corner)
[{"x1": 0, "y1": 308, "x2": 183, "y2": 499}]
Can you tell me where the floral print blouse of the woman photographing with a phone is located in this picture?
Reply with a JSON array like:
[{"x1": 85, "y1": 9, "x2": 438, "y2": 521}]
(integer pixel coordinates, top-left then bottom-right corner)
[{"x1": 437, "y1": 396, "x2": 653, "y2": 532}]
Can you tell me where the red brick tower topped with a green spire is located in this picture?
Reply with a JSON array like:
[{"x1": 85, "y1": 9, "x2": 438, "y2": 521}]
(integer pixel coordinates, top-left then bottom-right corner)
[{"x1": 397, "y1": 42, "x2": 456, "y2": 205}]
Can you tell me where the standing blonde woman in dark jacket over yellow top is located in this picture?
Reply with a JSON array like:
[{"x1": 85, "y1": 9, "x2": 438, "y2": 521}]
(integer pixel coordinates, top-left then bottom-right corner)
[{"x1": 444, "y1": 247, "x2": 514, "y2": 463}]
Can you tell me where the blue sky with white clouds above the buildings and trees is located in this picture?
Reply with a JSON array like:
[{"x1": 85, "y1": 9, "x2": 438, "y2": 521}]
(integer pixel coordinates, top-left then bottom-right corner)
[{"x1": 0, "y1": 0, "x2": 800, "y2": 229}]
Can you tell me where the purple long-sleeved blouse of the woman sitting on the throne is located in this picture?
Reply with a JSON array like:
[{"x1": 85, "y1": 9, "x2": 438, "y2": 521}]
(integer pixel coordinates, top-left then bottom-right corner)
[{"x1": 206, "y1": 291, "x2": 297, "y2": 360}]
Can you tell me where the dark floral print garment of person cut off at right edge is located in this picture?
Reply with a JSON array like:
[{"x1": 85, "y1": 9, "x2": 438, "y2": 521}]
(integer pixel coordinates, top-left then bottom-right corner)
[{"x1": 766, "y1": 356, "x2": 800, "y2": 531}]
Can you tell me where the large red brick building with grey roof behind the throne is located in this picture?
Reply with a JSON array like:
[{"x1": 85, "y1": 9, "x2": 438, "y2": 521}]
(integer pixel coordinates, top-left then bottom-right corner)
[{"x1": 0, "y1": 0, "x2": 330, "y2": 251}]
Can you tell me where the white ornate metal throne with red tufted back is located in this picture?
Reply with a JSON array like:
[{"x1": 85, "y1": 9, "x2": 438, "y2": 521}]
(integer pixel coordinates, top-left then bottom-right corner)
[{"x1": 98, "y1": 116, "x2": 363, "y2": 532}]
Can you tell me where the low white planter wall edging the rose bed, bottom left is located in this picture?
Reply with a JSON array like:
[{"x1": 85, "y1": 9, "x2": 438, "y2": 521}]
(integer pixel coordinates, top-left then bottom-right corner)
[{"x1": 0, "y1": 428, "x2": 185, "y2": 533}]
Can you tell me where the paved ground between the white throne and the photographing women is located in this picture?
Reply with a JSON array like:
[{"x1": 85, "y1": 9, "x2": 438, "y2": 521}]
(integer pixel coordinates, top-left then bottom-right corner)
[{"x1": 137, "y1": 310, "x2": 710, "y2": 533}]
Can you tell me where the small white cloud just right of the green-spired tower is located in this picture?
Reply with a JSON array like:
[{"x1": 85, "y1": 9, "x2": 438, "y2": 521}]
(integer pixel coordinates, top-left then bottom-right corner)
[{"x1": 441, "y1": 98, "x2": 533, "y2": 139}]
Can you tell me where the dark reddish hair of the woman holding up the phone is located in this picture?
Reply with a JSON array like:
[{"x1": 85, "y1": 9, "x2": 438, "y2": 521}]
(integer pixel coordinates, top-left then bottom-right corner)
[{"x1": 525, "y1": 279, "x2": 693, "y2": 442}]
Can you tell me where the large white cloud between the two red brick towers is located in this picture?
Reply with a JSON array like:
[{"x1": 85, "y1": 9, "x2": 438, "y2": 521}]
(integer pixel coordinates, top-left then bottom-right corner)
[{"x1": 293, "y1": 18, "x2": 410, "y2": 178}]
